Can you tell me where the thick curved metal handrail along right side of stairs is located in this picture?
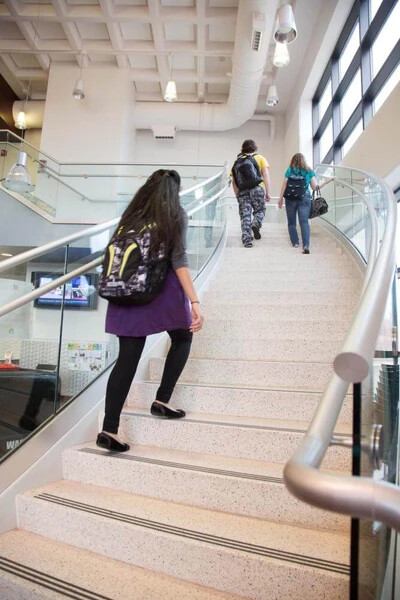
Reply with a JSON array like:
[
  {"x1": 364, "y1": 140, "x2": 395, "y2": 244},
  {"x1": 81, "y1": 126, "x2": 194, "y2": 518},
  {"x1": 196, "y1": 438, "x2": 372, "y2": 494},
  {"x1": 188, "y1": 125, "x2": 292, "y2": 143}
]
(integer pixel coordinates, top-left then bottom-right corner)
[{"x1": 284, "y1": 165, "x2": 400, "y2": 530}]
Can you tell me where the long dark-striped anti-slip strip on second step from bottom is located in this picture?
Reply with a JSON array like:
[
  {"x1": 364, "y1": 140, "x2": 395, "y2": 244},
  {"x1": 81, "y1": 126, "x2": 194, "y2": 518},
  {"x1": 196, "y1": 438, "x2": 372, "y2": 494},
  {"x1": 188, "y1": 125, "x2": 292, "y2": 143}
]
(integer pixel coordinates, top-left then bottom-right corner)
[{"x1": 35, "y1": 493, "x2": 350, "y2": 575}]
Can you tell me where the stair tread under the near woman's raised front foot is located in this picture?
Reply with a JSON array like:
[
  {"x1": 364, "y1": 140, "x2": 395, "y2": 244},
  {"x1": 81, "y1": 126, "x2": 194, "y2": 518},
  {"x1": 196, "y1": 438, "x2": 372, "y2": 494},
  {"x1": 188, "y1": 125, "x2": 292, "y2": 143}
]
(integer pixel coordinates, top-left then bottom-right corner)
[{"x1": 122, "y1": 406, "x2": 352, "y2": 436}]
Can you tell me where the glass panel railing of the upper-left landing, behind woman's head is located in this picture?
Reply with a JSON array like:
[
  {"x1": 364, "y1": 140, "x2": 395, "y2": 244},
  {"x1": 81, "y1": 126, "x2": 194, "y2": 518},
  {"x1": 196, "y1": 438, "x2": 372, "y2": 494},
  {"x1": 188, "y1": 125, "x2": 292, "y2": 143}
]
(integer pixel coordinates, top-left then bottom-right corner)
[{"x1": 0, "y1": 130, "x2": 223, "y2": 223}]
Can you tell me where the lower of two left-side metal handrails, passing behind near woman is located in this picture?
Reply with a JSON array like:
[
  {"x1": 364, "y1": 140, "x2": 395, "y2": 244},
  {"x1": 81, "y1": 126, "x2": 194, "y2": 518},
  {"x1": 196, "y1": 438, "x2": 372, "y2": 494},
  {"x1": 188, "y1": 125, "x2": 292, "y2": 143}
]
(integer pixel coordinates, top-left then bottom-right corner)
[{"x1": 0, "y1": 183, "x2": 229, "y2": 317}]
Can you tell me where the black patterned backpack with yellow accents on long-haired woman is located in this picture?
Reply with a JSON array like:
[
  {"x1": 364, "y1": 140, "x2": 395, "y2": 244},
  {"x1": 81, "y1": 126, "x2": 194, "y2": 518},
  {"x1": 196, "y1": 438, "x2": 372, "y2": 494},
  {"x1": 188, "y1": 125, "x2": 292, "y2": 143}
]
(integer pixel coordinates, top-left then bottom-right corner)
[{"x1": 98, "y1": 225, "x2": 170, "y2": 306}]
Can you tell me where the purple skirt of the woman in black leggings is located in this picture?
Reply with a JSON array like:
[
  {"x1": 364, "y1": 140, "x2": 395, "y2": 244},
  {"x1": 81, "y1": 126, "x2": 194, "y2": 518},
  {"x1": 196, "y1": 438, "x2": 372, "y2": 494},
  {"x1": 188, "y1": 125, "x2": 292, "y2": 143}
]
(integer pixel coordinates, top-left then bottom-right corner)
[{"x1": 106, "y1": 269, "x2": 192, "y2": 337}]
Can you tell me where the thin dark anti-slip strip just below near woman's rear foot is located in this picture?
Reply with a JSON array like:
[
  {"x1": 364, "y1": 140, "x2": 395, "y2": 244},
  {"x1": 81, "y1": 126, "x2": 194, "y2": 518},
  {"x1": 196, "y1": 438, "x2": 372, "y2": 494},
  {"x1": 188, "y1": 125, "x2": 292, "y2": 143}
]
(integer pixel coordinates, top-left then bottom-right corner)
[{"x1": 79, "y1": 448, "x2": 283, "y2": 484}]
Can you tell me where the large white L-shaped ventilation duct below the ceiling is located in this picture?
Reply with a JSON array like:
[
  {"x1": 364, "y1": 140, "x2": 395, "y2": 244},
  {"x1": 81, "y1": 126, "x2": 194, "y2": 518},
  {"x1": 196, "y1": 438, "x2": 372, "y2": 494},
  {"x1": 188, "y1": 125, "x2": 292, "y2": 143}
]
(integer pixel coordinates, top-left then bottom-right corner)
[{"x1": 133, "y1": 0, "x2": 278, "y2": 131}]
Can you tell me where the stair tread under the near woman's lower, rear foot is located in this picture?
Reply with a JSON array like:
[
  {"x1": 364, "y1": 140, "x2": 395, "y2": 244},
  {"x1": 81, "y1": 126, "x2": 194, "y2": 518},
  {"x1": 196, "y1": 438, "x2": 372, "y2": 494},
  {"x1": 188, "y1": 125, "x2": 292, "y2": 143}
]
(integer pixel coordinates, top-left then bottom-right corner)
[{"x1": 65, "y1": 442, "x2": 341, "y2": 485}]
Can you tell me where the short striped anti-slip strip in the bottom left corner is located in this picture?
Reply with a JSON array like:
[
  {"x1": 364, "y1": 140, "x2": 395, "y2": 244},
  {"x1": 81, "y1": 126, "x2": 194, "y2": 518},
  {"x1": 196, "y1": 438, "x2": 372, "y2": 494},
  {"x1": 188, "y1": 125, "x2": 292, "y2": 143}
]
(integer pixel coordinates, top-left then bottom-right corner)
[{"x1": 0, "y1": 556, "x2": 112, "y2": 600}]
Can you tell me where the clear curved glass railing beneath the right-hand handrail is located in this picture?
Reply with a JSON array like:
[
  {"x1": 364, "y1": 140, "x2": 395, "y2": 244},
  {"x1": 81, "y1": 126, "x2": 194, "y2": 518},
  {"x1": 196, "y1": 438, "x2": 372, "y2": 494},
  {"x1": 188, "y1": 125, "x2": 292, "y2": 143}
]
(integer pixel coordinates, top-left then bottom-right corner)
[{"x1": 317, "y1": 166, "x2": 399, "y2": 600}]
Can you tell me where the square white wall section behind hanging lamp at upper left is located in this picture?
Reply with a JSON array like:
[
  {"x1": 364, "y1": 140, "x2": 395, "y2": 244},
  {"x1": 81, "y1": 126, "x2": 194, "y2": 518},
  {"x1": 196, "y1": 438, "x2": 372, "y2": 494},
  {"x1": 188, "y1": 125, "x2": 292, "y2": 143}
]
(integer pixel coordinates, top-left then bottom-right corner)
[{"x1": 41, "y1": 63, "x2": 135, "y2": 163}]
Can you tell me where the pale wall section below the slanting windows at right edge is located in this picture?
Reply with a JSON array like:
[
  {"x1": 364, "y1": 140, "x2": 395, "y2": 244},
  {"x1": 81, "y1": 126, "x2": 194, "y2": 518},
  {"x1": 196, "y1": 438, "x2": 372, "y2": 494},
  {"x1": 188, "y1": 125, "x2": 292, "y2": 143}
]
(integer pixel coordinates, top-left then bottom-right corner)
[{"x1": 341, "y1": 83, "x2": 400, "y2": 180}]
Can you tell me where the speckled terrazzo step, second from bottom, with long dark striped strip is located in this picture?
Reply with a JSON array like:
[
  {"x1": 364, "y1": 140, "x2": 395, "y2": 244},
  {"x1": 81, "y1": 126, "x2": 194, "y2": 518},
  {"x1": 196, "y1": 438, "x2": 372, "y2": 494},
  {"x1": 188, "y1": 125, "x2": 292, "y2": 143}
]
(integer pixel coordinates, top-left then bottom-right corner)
[{"x1": 17, "y1": 481, "x2": 349, "y2": 600}]
